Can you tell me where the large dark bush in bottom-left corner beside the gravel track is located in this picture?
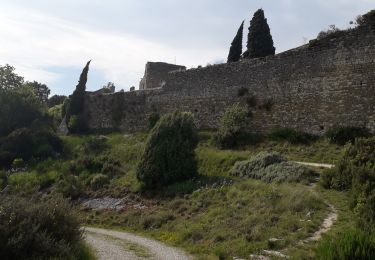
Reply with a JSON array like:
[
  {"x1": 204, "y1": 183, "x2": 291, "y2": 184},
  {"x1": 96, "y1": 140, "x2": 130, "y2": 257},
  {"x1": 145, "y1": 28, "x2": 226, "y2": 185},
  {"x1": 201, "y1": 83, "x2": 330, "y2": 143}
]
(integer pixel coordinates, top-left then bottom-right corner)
[{"x1": 0, "y1": 195, "x2": 82, "y2": 259}]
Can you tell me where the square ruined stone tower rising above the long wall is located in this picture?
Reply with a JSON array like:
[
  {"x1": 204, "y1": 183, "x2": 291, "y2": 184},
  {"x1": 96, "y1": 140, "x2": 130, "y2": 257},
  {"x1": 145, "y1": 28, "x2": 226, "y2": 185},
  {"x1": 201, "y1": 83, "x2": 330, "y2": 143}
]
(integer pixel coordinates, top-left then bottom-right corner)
[{"x1": 139, "y1": 62, "x2": 186, "y2": 89}]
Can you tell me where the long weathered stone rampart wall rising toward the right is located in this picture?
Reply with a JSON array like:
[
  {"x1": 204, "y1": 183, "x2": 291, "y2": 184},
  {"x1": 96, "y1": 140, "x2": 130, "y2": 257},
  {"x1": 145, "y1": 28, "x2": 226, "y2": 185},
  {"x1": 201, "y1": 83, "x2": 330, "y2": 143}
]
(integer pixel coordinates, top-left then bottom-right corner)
[{"x1": 85, "y1": 22, "x2": 375, "y2": 134}]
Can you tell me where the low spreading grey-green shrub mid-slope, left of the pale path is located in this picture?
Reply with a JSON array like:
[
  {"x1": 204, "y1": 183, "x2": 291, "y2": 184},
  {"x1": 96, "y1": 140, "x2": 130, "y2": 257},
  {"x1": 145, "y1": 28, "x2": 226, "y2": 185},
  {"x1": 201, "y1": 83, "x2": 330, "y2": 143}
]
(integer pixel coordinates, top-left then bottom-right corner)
[{"x1": 231, "y1": 153, "x2": 317, "y2": 183}]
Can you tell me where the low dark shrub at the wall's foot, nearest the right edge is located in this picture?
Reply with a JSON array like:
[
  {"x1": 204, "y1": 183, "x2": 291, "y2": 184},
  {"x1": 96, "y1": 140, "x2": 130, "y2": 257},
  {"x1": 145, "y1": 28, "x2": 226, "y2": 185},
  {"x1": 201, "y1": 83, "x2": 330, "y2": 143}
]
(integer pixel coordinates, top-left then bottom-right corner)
[{"x1": 326, "y1": 127, "x2": 370, "y2": 145}]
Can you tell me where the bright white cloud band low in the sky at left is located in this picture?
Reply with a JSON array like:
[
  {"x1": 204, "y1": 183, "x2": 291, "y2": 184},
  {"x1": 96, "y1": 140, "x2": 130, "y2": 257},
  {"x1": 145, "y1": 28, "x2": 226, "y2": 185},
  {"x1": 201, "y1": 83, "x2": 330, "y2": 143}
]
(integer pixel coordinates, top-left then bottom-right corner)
[{"x1": 0, "y1": 3, "x2": 223, "y2": 93}]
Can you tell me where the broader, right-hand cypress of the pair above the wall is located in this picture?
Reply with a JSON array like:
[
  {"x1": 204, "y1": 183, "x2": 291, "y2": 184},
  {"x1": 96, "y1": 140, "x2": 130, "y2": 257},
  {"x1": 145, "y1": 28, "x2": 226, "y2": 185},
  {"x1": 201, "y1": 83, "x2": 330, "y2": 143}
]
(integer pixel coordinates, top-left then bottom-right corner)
[{"x1": 243, "y1": 9, "x2": 275, "y2": 59}]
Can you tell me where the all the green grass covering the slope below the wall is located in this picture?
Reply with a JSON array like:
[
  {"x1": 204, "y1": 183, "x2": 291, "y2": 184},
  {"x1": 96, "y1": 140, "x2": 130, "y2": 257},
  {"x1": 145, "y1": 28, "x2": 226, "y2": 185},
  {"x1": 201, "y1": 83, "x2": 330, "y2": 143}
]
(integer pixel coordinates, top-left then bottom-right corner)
[{"x1": 6, "y1": 133, "x2": 350, "y2": 259}]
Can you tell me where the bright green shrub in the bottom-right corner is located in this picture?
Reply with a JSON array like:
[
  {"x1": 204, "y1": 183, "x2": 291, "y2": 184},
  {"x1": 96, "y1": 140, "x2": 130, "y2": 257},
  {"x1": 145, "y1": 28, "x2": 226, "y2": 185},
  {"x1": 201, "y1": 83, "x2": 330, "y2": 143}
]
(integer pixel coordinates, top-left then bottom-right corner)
[{"x1": 316, "y1": 230, "x2": 375, "y2": 260}]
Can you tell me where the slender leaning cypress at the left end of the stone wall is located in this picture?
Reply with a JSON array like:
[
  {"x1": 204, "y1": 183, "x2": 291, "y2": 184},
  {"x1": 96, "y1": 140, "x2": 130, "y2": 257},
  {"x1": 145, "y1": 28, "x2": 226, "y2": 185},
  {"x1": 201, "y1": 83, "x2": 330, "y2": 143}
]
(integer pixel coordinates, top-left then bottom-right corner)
[{"x1": 68, "y1": 60, "x2": 91, "y2": 117}]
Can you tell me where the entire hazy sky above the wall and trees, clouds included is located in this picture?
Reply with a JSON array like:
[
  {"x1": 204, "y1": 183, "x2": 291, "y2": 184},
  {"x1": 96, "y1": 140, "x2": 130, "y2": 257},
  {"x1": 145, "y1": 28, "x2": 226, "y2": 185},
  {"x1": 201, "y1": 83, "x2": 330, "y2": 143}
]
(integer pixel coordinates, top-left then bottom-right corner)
[{"x1": 0, "y1": 0, "x2": 375, "y2": 94}]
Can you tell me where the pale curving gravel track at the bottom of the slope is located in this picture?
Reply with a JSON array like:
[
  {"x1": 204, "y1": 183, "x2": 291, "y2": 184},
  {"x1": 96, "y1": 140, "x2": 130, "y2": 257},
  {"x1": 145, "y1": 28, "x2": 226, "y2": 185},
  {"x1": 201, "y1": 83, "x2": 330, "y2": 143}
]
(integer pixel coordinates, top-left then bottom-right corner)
[{"x1": 85, "y1": 227, "x2": 193, "y2": 260}]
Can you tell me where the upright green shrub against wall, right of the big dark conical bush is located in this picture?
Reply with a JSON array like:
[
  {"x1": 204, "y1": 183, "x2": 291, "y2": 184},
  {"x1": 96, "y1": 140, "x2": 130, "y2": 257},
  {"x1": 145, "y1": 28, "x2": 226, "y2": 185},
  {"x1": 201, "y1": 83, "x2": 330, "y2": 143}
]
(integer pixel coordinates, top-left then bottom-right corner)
[{"x1": 214, "y1": 104, "x2": 247, "y2": 149}]
